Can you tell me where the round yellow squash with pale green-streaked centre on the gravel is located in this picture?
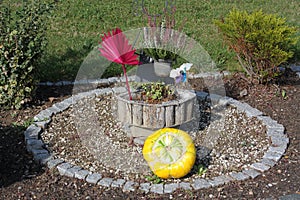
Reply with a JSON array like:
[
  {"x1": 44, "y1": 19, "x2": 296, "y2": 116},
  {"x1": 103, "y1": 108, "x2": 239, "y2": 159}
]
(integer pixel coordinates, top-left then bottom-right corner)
[{"x1": 143, "y1": 128, "x2": 196, "y2": 179}]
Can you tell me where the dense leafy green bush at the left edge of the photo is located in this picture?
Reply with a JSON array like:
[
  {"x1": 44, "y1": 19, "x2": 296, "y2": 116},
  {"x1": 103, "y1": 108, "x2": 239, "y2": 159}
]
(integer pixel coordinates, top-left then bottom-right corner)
[{"x1": 0, "y1": 1, "x2": 50, "y2": 108}]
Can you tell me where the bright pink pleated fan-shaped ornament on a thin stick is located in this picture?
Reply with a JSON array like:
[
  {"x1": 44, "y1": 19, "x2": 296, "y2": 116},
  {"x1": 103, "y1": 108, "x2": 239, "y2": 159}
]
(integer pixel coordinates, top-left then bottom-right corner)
[{"x1": 99, "y1": 28, "x2": 139, "y2": 100}]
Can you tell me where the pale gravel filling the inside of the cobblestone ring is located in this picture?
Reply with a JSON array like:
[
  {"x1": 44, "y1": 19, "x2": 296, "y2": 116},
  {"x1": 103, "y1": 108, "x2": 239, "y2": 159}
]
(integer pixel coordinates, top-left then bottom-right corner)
[{"x1": 42, "y1": 95, "x2": 269, "y2": 183}]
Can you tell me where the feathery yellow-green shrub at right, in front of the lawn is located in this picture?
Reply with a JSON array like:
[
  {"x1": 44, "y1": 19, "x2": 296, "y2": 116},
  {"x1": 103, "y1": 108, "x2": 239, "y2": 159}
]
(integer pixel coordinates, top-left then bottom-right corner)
[{"x1": 215, "y1": 10, "x2": 298, "y2": 83}]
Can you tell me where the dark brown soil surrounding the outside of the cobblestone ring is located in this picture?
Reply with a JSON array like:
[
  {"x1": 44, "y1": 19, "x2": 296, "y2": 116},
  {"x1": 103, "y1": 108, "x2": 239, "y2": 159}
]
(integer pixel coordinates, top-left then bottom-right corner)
[{"x1": 0, "y1": 74, "x2": 300, "y2": 199}]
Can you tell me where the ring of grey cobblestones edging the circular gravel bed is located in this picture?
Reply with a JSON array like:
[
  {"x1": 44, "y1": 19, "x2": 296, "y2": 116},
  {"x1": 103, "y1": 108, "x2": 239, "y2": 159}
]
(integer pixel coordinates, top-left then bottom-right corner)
[{"x1": 24, "y1": 74, "x2": 289, "y2": 194}]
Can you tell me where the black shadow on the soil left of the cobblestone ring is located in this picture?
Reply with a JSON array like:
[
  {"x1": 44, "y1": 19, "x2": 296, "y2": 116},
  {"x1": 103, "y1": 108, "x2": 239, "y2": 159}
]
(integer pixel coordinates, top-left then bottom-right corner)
[{"x1": 0, "y1": 124, "x2": 44, "y2": 188}]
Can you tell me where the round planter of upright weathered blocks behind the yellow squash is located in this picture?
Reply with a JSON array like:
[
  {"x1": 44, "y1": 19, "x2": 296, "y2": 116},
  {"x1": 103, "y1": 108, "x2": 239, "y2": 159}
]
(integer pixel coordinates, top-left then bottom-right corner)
[{"x1": 116, "y1": 90, "x2": 196, "y2": 140}]
